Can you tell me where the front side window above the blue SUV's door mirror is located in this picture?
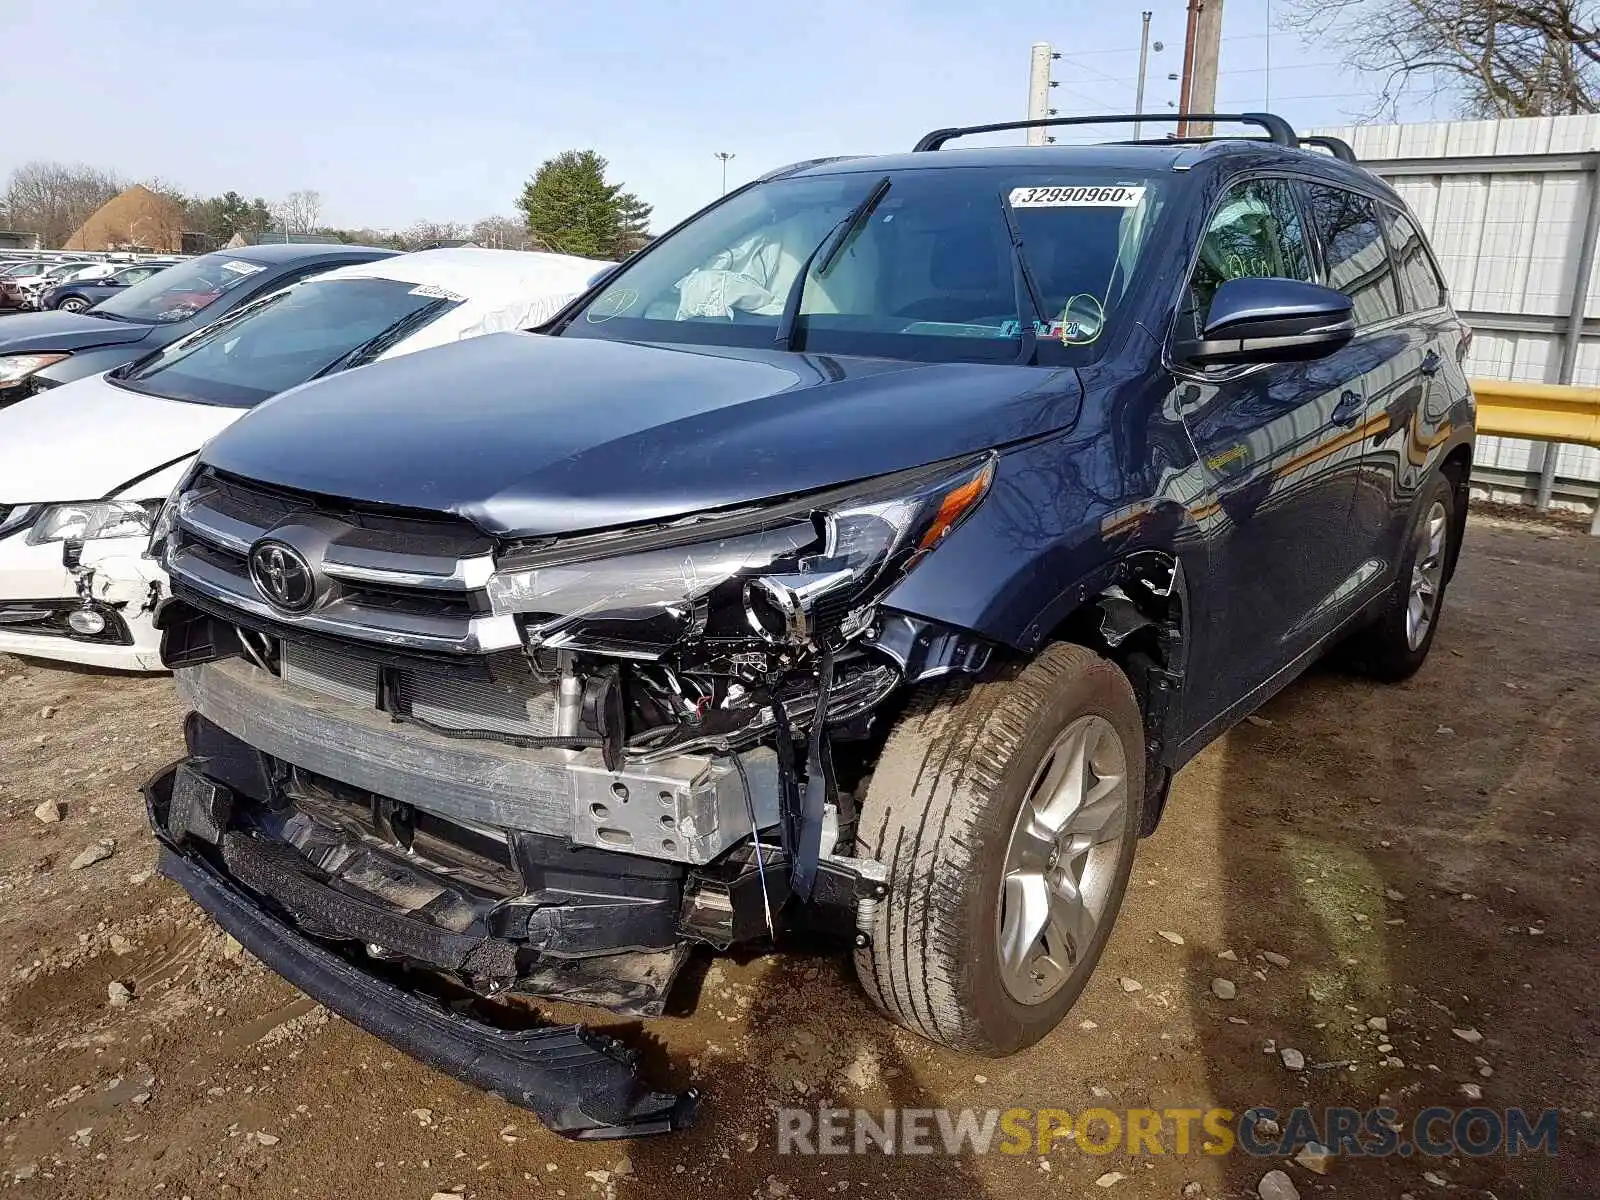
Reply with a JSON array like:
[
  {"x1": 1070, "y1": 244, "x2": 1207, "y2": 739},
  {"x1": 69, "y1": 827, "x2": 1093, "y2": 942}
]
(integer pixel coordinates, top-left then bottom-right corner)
[{"x1": 1189, "y1": 179, "x2": 1310, "y2": 334}]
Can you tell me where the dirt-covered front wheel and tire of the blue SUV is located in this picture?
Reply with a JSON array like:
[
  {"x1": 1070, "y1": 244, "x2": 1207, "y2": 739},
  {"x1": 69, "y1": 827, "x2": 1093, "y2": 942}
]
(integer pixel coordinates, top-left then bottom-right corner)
[{"x1": 856, "y1": 645, "x2": 1144, "y2": 1058}]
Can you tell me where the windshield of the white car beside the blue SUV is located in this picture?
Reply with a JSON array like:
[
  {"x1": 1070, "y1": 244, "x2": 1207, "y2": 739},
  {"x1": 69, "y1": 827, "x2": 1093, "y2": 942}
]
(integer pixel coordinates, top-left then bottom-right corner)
[{"x1": 114, "y1": 278, "x2": 461, "y2": 408}]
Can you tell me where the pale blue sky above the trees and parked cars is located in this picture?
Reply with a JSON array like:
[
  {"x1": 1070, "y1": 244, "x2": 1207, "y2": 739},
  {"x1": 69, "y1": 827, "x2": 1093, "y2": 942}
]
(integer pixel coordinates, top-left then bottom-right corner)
[{"x1": 0, "y1": 0, "x2": 1452, "y2": 232}]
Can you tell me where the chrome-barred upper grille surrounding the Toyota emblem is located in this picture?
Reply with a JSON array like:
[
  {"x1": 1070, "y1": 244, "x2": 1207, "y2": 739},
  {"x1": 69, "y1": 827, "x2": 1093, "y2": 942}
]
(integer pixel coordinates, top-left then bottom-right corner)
[{"x1": 166, "y1": 470, "x2": 520, "y2": 654}]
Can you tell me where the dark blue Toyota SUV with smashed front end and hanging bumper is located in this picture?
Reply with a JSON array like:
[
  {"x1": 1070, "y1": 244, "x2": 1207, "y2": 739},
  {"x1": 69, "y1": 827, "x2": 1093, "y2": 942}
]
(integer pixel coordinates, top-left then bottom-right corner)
[{"x1": 147, "y1": 114, "x2": 1474, "y2": 1136}]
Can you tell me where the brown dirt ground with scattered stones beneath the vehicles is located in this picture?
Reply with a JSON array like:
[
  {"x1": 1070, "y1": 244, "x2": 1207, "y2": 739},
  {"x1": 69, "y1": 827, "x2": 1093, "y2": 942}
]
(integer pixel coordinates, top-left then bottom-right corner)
[{"x1": 0, "y1": 517, "x2": 1600, "y2": 1200}]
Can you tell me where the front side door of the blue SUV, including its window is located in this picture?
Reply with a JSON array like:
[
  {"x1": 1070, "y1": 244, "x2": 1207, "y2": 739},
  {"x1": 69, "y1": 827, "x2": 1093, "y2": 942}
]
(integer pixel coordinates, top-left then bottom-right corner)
[{"x1": 1174, "y1": 178, "x2": 1381, "y2": 730}]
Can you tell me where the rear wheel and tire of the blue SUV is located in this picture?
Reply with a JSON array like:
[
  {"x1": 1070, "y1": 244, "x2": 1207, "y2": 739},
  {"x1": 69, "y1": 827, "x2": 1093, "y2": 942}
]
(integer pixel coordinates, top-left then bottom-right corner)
[{"x1": 1350, "y1": 474, "x2": 1461, "y2": 683}]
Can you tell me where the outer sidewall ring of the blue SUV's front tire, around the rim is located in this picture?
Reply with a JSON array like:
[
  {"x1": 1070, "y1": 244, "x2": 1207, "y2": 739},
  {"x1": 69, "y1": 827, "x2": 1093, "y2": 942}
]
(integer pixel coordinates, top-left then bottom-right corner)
[{"x1": 963, "y1": 659, "x2": 1144, "y2": 1053}]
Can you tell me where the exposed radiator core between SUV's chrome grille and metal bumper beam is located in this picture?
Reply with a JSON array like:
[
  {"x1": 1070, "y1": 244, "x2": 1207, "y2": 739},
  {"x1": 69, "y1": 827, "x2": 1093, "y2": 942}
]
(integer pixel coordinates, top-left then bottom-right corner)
[{"x1": 280, "y1": 643, "x2": 555, "y2": 738}]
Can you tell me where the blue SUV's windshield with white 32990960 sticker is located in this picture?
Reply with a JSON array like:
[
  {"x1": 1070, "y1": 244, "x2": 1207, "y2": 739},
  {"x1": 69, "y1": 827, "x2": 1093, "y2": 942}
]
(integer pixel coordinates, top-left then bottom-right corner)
[{"x1": 563, "y1": 166, "x2": 1165, "y2": 362}]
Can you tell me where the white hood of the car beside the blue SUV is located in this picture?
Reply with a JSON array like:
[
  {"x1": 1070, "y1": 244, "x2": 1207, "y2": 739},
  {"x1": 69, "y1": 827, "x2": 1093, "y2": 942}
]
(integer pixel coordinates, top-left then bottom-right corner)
[{"x1": 0, "y1": 374, "x2": 242, "y2": 504}]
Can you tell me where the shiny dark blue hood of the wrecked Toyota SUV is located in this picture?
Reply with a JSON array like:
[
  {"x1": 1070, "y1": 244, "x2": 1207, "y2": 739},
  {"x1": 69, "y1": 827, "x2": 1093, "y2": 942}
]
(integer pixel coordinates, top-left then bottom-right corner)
[{"x1": 193, "y1": 333, "x2": 1080, "y2": 536}]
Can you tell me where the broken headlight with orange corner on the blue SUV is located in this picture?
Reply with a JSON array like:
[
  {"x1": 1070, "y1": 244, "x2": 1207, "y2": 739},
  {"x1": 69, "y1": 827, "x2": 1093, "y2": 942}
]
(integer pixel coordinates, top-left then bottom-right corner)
[{"x1": 488, "y1": 456, "x2": 994, "y2": 658}]
